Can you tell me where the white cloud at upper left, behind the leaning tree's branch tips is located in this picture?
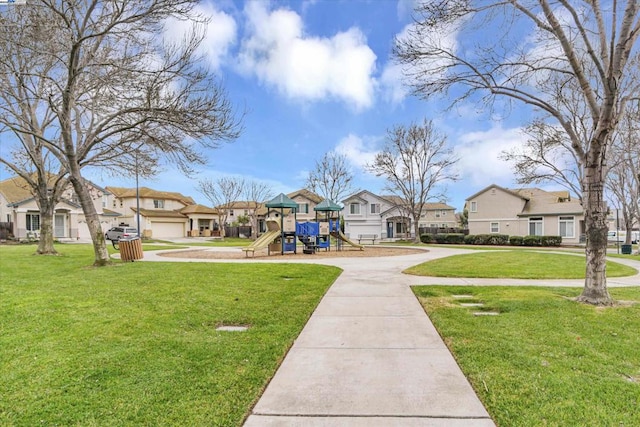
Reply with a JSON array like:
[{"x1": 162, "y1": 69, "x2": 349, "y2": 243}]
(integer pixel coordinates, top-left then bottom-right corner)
[{"x1": 165, "y1": 3, "x2": 237, "y2": 69}]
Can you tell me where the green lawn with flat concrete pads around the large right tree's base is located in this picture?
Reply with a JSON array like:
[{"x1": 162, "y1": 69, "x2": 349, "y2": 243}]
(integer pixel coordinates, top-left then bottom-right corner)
[{"x1": 414, "y1": 286, "x2": 640, "y2": 427}]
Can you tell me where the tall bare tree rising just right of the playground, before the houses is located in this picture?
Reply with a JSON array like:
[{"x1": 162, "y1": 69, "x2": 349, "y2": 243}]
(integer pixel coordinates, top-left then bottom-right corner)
[{"x1": 366, "y1": 120, "x2": 458, "y2": 241}]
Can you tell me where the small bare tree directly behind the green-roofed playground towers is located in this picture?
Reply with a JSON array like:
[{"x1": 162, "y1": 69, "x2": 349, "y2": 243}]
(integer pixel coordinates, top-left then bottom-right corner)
[{"x1": 306, "y1": 151, "x2": 354, "y2": 202}]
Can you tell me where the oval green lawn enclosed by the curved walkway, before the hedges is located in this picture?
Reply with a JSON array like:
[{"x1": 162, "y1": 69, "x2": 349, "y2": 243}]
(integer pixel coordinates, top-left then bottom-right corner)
[{"x1": 405, "y1": 251, "x2": 637, "y2": 279}]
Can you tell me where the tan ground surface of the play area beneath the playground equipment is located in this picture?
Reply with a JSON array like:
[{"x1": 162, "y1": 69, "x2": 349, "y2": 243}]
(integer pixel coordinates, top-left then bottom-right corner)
[{"x1": 158, "y1": 246, "x2": 426, "y2": 260}]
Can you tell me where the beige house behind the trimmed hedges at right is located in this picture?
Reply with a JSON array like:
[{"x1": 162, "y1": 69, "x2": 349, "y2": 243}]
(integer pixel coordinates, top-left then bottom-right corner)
[{"x1": 465, "y1": 184, "x2": 584, "y2": 244}]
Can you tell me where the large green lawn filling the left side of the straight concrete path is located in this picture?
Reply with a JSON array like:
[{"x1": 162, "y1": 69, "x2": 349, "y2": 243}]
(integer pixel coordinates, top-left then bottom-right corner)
[{"x1": 0, "y1": 245, "x2": 339, "y2": 426}]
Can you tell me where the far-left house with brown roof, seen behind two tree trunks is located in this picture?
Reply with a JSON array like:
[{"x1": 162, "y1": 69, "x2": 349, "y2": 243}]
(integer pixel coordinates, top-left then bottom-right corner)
[{"x1": 0, "y1": 177, "x2": 119, "y2": 240}]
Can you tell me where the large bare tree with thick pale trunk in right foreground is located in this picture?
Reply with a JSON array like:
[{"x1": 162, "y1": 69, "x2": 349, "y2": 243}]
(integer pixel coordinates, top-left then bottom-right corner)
[{"x1": 394, "y1": 0, "x2": 640, "y2": 304}]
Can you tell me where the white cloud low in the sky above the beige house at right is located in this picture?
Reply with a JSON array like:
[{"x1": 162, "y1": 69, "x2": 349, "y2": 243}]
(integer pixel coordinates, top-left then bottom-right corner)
[{"x1": 454, "y1": 126, "x2": 526, "y2": 187}]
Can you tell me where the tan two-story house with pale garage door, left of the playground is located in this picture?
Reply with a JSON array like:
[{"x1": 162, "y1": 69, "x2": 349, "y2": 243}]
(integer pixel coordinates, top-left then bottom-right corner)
[{"x1": 106, "y1": 187, "x2": 218, "y2": 239}]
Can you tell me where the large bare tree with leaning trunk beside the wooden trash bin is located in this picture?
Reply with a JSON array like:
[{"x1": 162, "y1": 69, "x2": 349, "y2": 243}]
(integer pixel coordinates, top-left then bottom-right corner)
[{"x1": 0, "y1": 0, "x2": 240, "y2": 265}]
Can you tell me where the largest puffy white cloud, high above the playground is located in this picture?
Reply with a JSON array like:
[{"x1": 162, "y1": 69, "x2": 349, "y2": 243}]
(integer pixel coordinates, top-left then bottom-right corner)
[{"x1": 239, "y1": 2, "x2": 376, "y2": 110}]
